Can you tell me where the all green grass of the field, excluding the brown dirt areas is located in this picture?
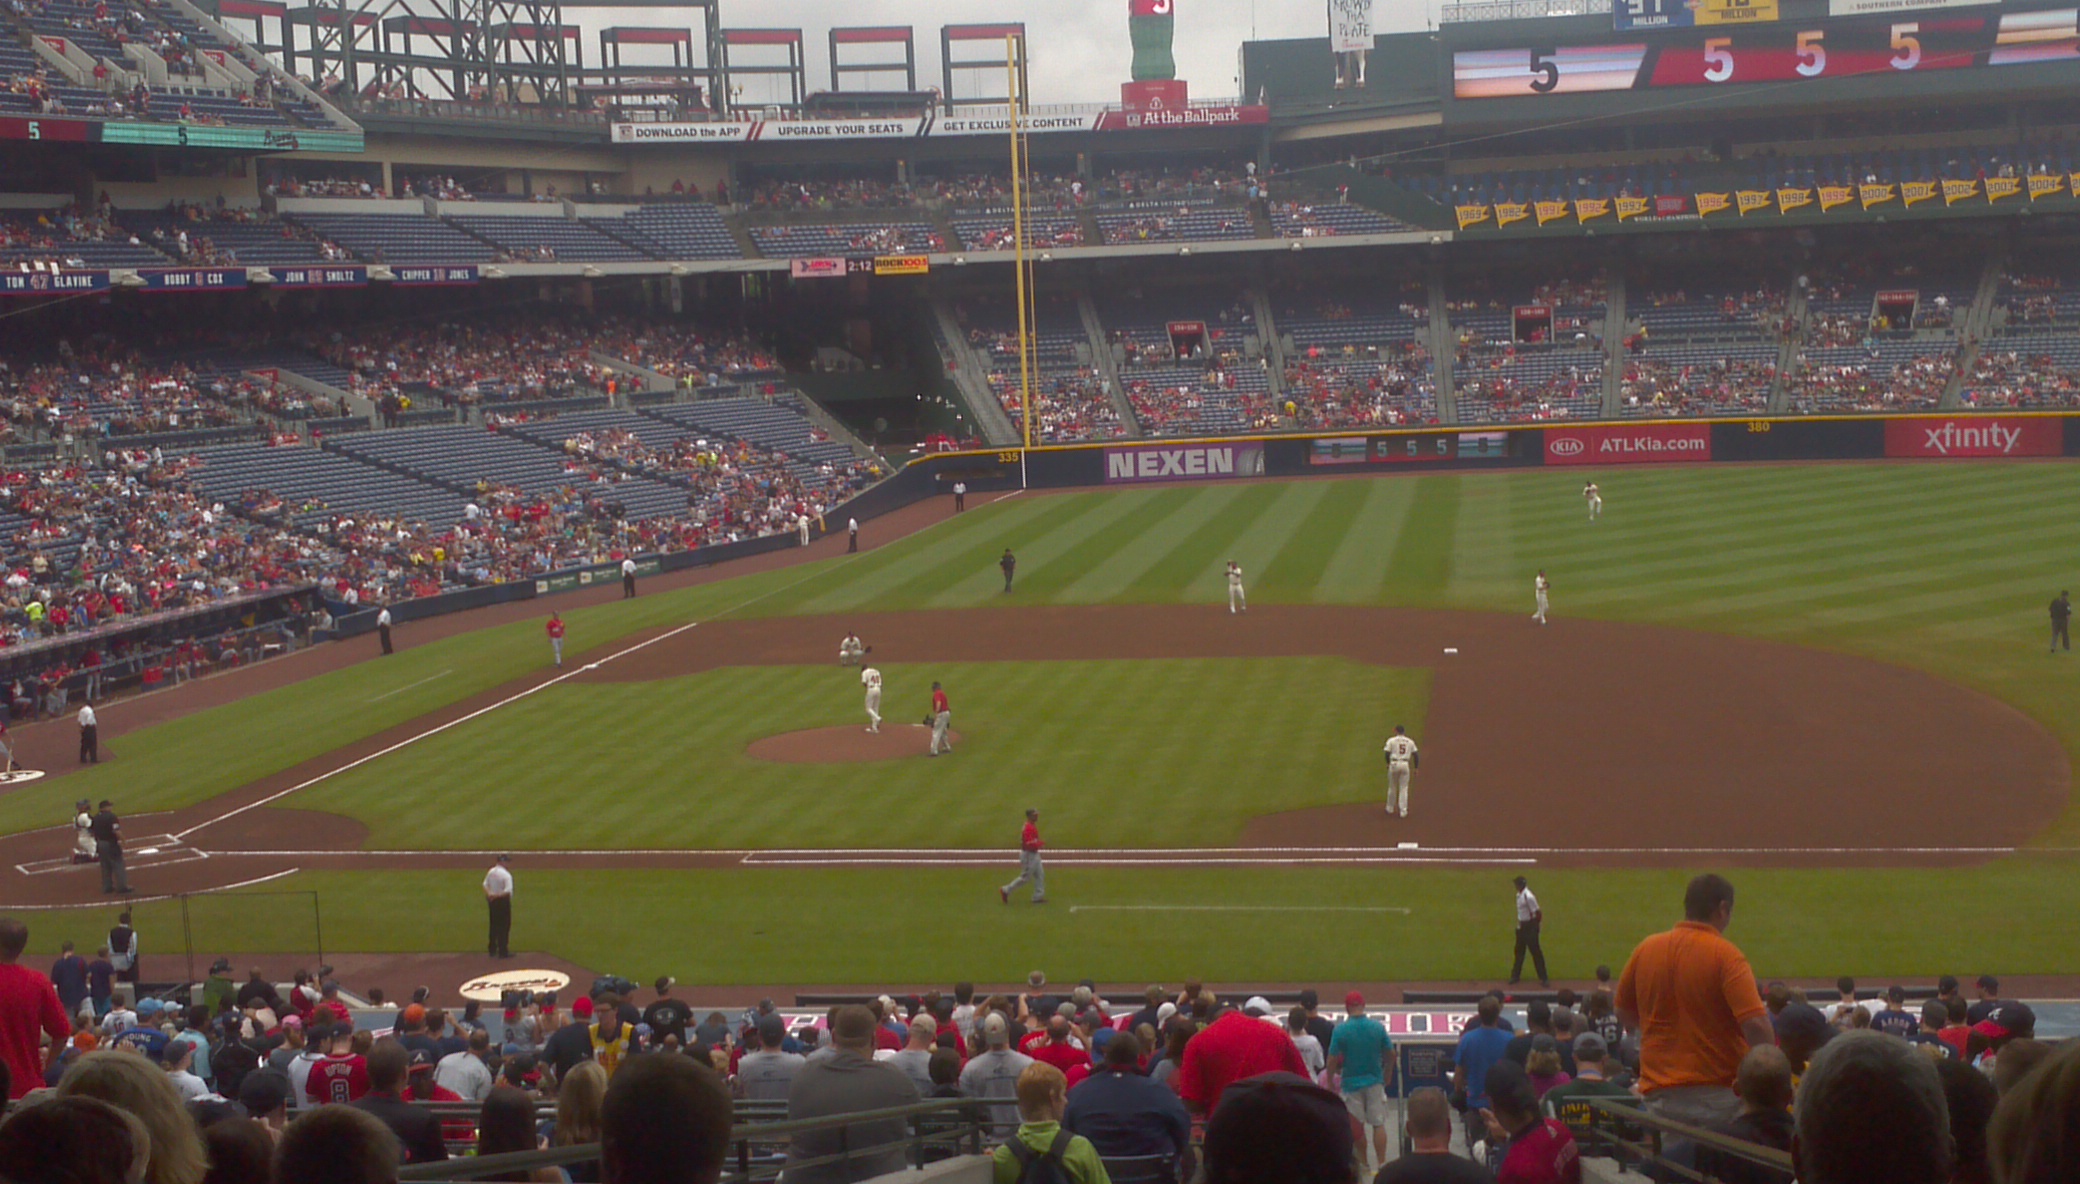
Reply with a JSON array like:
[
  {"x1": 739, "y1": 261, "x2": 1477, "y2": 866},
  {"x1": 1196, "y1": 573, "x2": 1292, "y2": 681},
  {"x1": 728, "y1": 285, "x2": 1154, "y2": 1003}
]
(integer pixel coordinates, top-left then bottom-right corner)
[{"x1": 12, "y1": 462, "x2": 2080, "y2": 982}]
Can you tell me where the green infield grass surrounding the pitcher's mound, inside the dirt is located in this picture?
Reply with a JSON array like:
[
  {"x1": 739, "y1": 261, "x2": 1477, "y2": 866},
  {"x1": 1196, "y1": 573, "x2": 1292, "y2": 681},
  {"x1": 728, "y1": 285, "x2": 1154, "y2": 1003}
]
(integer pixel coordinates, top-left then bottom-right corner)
[{"x1": 291, "y1": 658, "x2": 1429, "y2": 851}]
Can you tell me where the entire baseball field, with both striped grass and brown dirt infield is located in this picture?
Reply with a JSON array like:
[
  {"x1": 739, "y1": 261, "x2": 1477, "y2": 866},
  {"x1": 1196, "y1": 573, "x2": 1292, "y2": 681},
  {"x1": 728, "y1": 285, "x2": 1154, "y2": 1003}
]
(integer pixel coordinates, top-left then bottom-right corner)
[{"x1": 0, "y1": 462, "x2": 2080, "y2": 986}]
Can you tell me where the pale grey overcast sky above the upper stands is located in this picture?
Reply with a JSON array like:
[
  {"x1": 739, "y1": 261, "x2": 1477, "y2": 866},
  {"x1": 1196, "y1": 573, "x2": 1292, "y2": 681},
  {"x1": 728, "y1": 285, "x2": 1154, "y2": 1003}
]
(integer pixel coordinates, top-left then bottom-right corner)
[{"x1": 564, "y1": 0, "x2": 1437, "y2": 102}]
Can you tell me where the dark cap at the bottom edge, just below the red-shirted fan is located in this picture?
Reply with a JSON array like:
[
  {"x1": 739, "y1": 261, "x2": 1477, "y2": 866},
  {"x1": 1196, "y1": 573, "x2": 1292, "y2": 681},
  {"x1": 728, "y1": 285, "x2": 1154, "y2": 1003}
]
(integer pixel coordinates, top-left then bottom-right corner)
[{"x1": 1204, "y1": 1074, "x2": 1352, "y2": 1184}]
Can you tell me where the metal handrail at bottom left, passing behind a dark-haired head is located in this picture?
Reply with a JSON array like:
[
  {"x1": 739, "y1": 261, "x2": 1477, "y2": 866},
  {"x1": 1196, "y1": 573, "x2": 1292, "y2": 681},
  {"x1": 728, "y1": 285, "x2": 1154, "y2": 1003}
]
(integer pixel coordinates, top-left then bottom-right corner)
[{"x1": 397, "y1": 1099, "x2": 992, "y2": 1184}]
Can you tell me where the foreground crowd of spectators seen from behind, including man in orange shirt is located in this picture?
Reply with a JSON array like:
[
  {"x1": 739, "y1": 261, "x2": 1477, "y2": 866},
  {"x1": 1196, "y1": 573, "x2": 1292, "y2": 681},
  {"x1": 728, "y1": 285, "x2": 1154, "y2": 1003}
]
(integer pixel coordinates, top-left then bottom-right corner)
[{"x1": 0, "y1": 874, "x2": 2080, "y2": 1184}]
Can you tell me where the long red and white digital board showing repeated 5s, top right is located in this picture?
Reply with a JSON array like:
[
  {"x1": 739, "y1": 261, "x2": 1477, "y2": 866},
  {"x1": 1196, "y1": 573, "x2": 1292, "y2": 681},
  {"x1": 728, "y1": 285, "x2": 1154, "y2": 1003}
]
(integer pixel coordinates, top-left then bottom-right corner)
[{"x1": 1450, "y1": 0, "x2": 2080, "y2": 114}]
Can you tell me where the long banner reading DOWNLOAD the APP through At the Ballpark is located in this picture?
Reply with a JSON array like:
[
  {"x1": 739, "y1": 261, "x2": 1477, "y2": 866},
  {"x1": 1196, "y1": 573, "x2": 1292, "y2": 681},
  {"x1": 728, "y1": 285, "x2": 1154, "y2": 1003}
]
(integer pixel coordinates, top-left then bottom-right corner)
[{"x1": 612, "y1": 104, "x2": 1271, "y2": 144}]
